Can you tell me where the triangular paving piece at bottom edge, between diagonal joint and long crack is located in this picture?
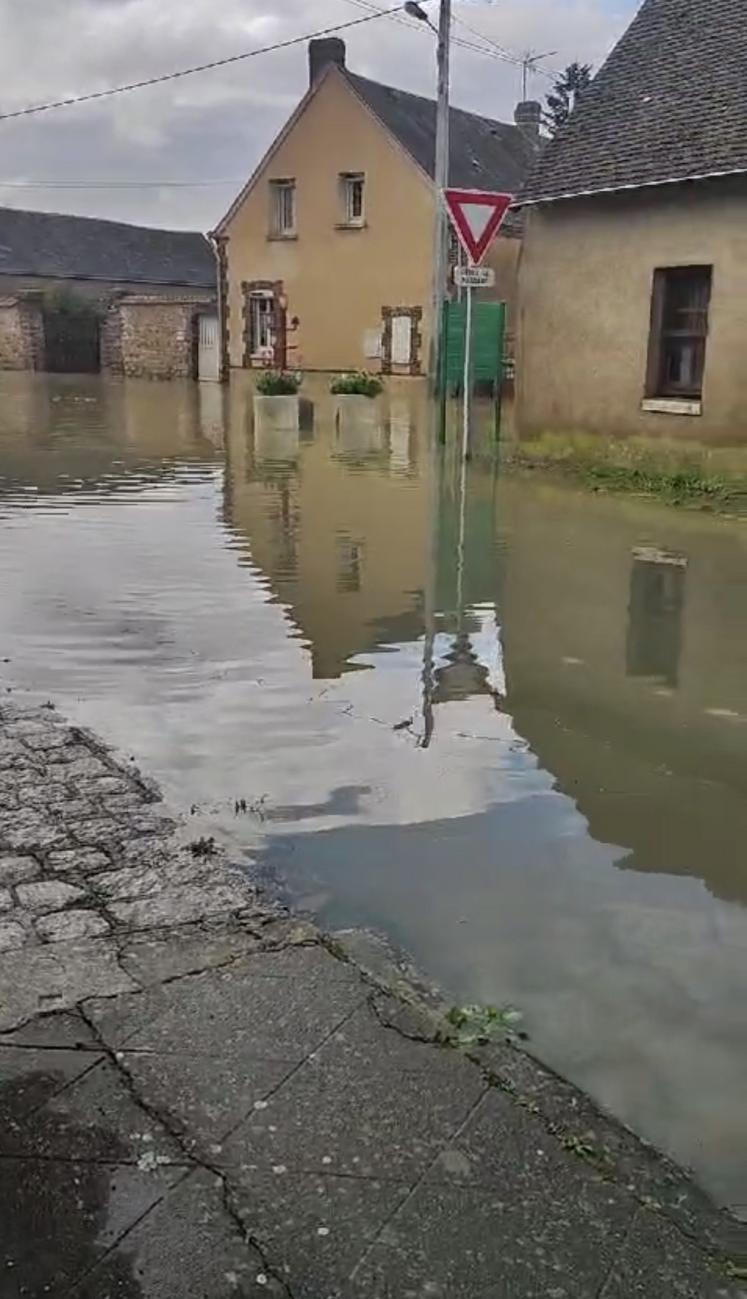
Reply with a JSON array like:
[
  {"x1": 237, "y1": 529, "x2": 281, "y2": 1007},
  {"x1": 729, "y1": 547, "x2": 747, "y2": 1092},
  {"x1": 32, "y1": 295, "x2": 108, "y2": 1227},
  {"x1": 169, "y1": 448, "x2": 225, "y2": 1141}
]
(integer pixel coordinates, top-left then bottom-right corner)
[{"x1": 71, "y1": 1172, "x2": 287, "y2": 1299}]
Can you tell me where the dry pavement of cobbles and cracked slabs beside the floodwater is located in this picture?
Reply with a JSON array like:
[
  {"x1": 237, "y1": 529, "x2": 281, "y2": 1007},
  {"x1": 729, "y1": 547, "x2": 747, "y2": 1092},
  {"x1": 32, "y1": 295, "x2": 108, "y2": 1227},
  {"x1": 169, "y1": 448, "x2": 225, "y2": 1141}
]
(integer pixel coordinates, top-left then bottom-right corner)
[{"x1": 0, "y1": 707, "x2": 747, "y2": 1299}]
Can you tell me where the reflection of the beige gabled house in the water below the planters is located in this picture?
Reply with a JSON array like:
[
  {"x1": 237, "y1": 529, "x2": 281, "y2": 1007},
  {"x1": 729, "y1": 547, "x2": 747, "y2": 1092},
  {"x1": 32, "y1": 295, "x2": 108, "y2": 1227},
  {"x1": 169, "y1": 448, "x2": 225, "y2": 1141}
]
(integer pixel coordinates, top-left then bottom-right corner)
[{"x1": 225, "y1": 386, "x2": 504, "y2": 688}]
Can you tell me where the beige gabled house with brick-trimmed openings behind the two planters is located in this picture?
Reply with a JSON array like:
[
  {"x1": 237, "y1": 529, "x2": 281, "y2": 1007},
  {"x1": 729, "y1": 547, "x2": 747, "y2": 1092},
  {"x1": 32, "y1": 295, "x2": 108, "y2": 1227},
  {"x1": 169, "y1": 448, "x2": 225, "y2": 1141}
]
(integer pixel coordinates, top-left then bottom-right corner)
[{"x1": 213, "y1": 39, "x2": 539, "y2": 374}]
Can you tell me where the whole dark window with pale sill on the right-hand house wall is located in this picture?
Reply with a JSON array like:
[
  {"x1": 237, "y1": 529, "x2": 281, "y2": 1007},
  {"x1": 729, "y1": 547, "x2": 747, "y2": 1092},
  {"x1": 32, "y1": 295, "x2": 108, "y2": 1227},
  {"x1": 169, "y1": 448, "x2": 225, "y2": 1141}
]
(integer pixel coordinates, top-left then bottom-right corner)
[{"x1": 646, "y1": 266, "x2": 712, "y2": 400}]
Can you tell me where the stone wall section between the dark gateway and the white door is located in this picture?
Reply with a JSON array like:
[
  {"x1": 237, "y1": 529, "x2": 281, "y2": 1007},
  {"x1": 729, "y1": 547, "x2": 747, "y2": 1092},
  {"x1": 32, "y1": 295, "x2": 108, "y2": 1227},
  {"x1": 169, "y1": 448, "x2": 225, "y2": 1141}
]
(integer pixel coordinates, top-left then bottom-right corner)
[{"x1": 101, "y1": 294, "x2": 214, "y2": 379}]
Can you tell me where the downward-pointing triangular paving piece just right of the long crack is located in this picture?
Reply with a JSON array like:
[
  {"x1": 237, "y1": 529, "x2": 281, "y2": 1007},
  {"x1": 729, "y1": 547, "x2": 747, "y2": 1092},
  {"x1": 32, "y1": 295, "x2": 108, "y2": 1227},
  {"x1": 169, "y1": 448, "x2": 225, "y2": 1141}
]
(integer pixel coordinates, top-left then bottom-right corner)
[{"x1": 122, "y1": 1043, "x2": 296, "y2": 1160}]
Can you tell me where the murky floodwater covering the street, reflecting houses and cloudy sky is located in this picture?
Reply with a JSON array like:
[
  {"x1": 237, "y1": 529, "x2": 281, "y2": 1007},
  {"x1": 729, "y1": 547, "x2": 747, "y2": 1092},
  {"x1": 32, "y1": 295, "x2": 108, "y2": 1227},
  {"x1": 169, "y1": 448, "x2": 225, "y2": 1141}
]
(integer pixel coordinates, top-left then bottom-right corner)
[{"x1": 0, "y1": 375, "x2": 747, "y2": 1211}]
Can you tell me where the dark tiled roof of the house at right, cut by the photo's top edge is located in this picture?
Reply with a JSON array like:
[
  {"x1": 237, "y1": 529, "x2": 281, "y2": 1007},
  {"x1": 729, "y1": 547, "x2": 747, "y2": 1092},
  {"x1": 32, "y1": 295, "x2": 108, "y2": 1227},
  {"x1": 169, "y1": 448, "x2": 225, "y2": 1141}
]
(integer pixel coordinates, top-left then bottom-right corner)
[{"x1": 521, "y1": 0, "x2": 747, "y2": 201}]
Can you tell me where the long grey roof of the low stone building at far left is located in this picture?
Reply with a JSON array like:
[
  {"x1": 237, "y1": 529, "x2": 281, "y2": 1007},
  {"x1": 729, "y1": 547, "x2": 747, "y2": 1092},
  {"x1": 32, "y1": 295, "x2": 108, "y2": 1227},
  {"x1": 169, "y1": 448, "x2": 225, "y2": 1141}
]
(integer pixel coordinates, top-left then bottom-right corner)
[{"x1": 0, "y1": 208, "x2": 216, "y2": 288}]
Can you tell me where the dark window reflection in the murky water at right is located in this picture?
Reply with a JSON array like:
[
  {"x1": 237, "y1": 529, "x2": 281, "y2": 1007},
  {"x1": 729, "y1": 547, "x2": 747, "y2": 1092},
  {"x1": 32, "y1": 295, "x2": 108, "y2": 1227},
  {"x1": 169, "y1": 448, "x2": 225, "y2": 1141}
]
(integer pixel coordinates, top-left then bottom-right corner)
[{"x1": 627, "y1": 546, "x2": 687, "y2": 686}]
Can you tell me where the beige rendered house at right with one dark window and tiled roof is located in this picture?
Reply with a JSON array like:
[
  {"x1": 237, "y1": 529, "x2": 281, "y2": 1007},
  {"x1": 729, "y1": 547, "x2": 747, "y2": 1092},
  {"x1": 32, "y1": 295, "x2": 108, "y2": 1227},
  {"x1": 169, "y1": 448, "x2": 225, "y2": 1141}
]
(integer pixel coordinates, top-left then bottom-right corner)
[{"x1": 517, "y1": 0, "x2": 747, "y2": 444}]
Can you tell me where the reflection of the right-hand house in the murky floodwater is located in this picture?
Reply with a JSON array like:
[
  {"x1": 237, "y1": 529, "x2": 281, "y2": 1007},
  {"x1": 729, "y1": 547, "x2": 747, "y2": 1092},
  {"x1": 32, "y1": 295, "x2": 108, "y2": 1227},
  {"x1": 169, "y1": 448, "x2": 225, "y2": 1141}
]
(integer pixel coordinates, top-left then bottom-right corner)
[{"x1": 501, "y1": 483, "x2": 747, "y2": 903}]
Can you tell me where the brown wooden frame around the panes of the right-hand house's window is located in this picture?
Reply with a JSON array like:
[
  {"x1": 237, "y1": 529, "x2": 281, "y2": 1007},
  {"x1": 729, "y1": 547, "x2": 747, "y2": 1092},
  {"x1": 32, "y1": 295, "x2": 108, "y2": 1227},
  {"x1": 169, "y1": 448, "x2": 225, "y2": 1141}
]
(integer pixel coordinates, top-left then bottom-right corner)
[{"x1": 644, "y1": 264, "x2": 713, "y2": 403}]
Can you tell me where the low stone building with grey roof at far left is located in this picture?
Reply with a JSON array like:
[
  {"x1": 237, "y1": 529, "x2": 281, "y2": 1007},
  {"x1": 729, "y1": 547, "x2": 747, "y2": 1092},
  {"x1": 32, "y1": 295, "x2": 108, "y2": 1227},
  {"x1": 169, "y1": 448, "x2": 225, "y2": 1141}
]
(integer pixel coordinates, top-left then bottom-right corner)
[{"x1": 0, "y1": 208, "x2": 217, "y2": 377}]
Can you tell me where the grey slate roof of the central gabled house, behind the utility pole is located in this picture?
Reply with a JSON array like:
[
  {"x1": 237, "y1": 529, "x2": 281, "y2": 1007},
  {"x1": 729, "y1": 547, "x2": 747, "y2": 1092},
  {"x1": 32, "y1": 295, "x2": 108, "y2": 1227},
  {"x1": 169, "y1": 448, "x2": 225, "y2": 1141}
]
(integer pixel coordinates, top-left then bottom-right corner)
[{"x1": 344, "y1": 69, "x2": 537, "y2": 194}]
